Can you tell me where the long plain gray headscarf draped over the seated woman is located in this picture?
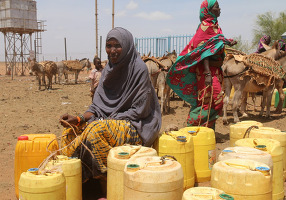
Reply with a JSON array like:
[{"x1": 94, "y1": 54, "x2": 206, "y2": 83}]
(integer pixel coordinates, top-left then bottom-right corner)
[{"x1": 87, "y1": 27, "x2": 162, "y2": 146}]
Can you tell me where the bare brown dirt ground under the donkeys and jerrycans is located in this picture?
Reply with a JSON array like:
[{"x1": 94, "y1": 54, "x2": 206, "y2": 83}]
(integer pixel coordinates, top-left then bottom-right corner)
[{"x1": 0, "y1": 63, "x2": 286, "y2": 200}]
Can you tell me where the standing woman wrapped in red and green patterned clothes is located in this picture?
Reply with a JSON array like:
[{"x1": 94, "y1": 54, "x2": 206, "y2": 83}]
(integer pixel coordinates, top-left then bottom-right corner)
[{"x1": 167, "y1": 0, "x2": 236, "y2": 129}]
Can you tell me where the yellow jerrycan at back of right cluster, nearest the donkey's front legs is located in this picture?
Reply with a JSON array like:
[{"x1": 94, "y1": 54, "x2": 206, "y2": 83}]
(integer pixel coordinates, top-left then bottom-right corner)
[{"x1": 229, "y1": 120, "x2": 263, "y2": 147}]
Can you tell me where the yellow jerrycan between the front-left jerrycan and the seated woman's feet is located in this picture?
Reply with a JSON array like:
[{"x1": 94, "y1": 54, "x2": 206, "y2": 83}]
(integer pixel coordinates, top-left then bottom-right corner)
[{"x1": 46, "y1": 155, "x2": 82, "y2": 200}]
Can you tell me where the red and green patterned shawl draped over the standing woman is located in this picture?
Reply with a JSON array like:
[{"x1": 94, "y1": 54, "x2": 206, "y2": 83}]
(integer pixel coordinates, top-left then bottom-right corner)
[{"x1": 167, "y1": 0, "x2": 232, "y2": 106}]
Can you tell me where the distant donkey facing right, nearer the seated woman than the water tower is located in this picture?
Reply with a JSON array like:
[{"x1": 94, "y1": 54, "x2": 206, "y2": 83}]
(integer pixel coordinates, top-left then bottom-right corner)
[{"x1": 61, "y1": 58, "x2": 91, "y2": 84}]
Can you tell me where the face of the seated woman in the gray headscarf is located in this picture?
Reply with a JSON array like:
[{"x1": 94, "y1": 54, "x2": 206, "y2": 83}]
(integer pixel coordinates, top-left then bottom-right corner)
[{"x1": 105, "y1": 38, "x2": 122, "y2": 64}]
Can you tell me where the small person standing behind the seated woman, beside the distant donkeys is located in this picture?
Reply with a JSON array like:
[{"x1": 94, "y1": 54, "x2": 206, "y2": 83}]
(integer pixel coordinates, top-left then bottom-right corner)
[{"x1": 89, "y1": 56, "x2": 103, "y2": 100}]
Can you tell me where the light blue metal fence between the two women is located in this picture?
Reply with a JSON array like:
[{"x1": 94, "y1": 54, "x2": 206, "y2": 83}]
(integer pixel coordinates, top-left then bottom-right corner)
[{"x1": 135, "y1": 35, "x2": 193, "y2": 57}]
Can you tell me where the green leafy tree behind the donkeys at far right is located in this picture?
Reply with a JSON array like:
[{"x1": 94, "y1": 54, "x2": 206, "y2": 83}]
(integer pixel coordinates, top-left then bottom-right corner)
[{"x1": 252, "y1": 12, "x2": 286, "y2": 46}]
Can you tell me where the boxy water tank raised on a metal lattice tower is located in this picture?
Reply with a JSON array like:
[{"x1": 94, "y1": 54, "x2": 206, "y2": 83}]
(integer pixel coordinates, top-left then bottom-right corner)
[{"x1": 0, "y1": 0, "x2": 45, "y2": 78}]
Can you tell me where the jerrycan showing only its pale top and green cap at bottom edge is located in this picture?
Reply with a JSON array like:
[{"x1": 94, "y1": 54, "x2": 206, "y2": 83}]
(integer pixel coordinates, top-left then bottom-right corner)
[{"x1": 182, "y1": 187, "x2": 233, "y2": 200}]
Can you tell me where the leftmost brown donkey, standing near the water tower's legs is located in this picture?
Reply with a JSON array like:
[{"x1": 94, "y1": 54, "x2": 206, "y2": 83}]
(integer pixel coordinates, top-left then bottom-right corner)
[{"x1": 28, "y1": 58, "x2": 57, "y2": 90}]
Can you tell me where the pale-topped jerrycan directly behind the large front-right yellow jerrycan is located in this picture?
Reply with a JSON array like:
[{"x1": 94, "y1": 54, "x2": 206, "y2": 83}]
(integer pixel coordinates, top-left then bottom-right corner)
[{"x1": 217, "y1": 146, "x2": 273, "y2": 171}]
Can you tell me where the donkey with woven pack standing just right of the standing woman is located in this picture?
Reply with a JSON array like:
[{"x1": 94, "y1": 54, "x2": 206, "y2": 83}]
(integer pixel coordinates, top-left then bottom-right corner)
[{"x1": 222, "y1": 42, "x2": 283, "y2": 124}]
